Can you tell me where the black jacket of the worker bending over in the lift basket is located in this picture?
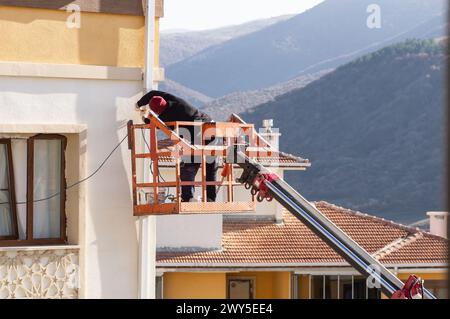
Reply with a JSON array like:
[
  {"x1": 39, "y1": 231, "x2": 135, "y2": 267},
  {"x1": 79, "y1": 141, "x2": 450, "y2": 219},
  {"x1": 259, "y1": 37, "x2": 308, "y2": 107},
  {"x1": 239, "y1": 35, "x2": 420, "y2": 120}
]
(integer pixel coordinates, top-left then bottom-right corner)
[{"x1": 137, "y1": 90, "x2": 212, "y2": 160}]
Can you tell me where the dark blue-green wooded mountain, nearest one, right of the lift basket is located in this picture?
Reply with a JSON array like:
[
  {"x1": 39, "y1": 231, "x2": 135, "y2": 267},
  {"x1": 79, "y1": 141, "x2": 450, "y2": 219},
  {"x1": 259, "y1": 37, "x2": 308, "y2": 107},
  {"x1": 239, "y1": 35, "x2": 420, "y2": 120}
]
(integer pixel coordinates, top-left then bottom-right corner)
[{"x1": 241, "y1": 40, "x2": 448, "y2": 223}]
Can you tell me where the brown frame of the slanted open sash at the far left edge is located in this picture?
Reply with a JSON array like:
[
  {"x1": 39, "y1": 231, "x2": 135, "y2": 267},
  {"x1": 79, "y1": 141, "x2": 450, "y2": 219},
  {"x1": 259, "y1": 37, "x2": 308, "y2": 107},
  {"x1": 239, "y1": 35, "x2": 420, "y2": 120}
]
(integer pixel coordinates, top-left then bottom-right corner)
[{"x1": 0, "y1": 138, "x2": 19, "y2": 241}]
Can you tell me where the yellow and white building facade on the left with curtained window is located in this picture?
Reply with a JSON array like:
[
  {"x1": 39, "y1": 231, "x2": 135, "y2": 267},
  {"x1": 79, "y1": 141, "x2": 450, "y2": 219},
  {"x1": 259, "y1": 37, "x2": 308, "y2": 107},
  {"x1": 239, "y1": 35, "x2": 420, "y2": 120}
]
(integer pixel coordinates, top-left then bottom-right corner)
[{"x1": 0, "y1": 0, "x2": 163, "y2": 298}]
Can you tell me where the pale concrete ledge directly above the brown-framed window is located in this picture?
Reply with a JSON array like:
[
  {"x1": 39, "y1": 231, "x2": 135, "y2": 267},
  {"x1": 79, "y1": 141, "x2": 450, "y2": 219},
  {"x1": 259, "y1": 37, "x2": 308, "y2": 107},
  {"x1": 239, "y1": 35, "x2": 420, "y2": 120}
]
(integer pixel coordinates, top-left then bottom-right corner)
[{"x1": 0, "y1": 123, "x2": 87, "y2": 134}]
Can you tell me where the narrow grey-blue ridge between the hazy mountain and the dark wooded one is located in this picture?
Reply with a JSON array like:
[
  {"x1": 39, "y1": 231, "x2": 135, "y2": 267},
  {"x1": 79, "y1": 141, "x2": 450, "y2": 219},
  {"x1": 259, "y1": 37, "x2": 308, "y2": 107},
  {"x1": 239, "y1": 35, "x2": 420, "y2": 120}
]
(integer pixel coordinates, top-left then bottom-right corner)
[{"x1": 202, "y1": 70, "x2": 331, "y2": 121}]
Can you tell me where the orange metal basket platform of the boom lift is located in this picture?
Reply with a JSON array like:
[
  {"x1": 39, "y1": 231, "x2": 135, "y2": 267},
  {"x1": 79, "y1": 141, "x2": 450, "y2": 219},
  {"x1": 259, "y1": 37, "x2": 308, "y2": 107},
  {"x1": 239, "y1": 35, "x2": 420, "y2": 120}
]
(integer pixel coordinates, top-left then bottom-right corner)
[{"x1": 128, "y1": 114, "x2": 288, "y2": 216}]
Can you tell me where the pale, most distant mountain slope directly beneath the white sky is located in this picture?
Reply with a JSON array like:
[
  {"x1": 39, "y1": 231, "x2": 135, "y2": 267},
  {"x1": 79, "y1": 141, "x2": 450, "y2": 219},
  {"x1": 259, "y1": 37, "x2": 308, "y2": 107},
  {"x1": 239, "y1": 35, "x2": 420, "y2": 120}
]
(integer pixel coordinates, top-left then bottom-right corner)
[{"x1": 160, "y1": 15, "x2": 292, "y2": 67}]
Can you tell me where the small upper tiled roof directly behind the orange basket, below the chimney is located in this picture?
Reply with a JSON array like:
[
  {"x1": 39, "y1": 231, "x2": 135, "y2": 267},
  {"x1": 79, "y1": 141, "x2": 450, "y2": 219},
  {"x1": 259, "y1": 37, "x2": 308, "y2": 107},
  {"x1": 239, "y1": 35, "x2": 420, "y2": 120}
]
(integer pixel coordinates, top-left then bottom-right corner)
[{"x1": 158, "y1": 139, "x2": 311, "y2": 168}]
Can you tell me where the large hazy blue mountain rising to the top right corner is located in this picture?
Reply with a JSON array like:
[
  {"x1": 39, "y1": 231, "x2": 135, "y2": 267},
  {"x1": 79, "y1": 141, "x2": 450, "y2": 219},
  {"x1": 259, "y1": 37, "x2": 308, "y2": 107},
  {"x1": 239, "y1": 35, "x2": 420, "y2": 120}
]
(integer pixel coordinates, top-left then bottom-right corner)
[{"x1": 166, "y1": 0, "x2": 447, "y2": 97}]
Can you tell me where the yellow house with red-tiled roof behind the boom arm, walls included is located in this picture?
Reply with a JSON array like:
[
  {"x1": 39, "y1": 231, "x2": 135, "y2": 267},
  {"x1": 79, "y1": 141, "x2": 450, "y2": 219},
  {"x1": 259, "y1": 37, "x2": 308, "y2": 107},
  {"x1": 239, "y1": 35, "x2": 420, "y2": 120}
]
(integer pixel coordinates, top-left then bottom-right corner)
[{"x1": 157, "y1": 202, "x2": 448, "y2": 299}]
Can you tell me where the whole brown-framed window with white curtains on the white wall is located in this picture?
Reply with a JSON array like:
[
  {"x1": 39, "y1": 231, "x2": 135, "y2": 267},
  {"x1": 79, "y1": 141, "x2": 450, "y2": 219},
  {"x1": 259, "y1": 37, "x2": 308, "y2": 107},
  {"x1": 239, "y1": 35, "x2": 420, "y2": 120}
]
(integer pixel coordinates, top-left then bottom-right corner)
[{"x1": 0, "y1": 134, "x2": 67, "y2": 246}]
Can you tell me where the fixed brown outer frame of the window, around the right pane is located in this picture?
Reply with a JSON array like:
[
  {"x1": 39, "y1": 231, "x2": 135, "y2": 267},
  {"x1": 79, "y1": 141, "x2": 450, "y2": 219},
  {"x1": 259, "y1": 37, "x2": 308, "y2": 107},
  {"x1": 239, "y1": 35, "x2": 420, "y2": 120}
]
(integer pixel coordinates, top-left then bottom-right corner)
[{"x1": 0, "y1": 134, "x2": 67, "y2": 247}]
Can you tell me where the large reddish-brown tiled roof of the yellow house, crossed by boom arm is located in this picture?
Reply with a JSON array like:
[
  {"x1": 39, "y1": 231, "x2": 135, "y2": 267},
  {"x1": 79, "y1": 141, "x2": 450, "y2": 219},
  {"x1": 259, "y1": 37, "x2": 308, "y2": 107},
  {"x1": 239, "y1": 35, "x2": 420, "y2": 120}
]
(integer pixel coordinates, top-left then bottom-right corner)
[{"x1": 157, "y1": 202, "x2": 448, "y2": 267}]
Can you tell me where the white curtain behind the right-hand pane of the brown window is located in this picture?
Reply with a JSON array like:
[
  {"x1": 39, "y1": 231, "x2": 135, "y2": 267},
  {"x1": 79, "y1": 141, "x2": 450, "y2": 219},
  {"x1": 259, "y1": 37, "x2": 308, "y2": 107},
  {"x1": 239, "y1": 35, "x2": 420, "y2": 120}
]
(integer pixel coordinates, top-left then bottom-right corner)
[{"x1": 33, "y1": 140, "x2": 62, "y2": 239}]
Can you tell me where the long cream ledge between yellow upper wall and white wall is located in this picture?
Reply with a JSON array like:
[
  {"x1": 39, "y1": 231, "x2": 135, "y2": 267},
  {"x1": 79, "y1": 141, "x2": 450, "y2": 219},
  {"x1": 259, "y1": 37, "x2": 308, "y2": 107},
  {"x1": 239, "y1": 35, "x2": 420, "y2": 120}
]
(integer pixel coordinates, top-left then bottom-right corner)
[{"x1": 0, "y1": 62, "x2": 142, "y2": 81}]
